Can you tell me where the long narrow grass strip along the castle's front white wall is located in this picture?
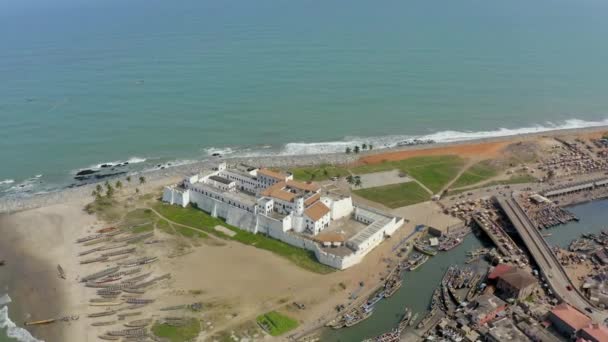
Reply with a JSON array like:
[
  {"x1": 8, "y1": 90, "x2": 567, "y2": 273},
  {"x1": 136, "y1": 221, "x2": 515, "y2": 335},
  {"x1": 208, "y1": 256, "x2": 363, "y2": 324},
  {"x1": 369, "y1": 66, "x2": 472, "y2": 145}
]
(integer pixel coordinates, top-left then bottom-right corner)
[{"x1": 154, "y1": 202, "x2": 335, "y2": 274}]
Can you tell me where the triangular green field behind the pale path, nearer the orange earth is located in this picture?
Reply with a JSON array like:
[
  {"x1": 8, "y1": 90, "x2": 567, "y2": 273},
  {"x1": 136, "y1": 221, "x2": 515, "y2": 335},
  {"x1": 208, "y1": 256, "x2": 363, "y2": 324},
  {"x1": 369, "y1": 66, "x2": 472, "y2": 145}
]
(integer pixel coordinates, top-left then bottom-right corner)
[{"x1": 351, "y1": 155, "x2": 465, "y2": 193}]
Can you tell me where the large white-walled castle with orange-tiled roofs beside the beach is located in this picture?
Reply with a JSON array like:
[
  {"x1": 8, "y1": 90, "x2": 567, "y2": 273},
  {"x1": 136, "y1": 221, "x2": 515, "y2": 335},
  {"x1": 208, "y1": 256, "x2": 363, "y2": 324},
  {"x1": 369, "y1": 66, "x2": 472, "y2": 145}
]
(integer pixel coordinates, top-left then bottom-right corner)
[{"x1": 163, "y1": 163, "x2": 404, "y2": 269}]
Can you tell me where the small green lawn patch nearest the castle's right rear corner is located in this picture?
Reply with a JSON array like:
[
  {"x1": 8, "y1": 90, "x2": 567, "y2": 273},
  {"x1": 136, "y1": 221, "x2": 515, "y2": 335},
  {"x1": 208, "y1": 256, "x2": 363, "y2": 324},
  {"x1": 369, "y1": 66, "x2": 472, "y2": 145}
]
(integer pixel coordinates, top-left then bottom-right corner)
[{"x1": 355, "y1": 182, "x2": 431, "y2": 208}]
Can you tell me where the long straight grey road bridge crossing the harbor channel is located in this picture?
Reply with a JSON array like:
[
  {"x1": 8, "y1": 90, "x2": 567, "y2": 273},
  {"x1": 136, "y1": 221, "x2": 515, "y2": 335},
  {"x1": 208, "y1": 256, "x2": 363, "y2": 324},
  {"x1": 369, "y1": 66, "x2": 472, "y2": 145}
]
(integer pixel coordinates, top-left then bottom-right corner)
[{"x1": 497, "y1": 195, "x2": 607, "y2": 322}]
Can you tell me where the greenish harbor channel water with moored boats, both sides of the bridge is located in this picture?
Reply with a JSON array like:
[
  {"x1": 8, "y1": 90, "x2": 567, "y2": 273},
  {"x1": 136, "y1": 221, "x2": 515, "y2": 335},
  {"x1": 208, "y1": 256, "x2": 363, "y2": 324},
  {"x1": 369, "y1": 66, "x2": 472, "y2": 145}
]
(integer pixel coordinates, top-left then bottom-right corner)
[{"x1": 322, "y1": 200, "x2": 608, "y2": 342}]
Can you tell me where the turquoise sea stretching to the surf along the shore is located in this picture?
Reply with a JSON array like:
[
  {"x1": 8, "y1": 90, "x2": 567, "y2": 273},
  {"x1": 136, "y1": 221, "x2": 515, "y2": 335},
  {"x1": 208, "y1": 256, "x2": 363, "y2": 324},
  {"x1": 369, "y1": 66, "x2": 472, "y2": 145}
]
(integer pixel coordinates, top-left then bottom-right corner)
[{"x1": 0, "y1": 0, "x2": 608, "y2": 194}]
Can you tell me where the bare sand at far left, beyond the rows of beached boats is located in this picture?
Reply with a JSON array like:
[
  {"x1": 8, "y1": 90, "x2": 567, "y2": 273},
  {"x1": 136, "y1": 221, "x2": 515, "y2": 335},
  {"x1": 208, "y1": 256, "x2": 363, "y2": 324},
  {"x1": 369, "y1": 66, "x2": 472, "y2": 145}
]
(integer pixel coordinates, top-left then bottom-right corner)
[{"x1": 0, "y1": 202, "x2": 95, "y2": 342}]
